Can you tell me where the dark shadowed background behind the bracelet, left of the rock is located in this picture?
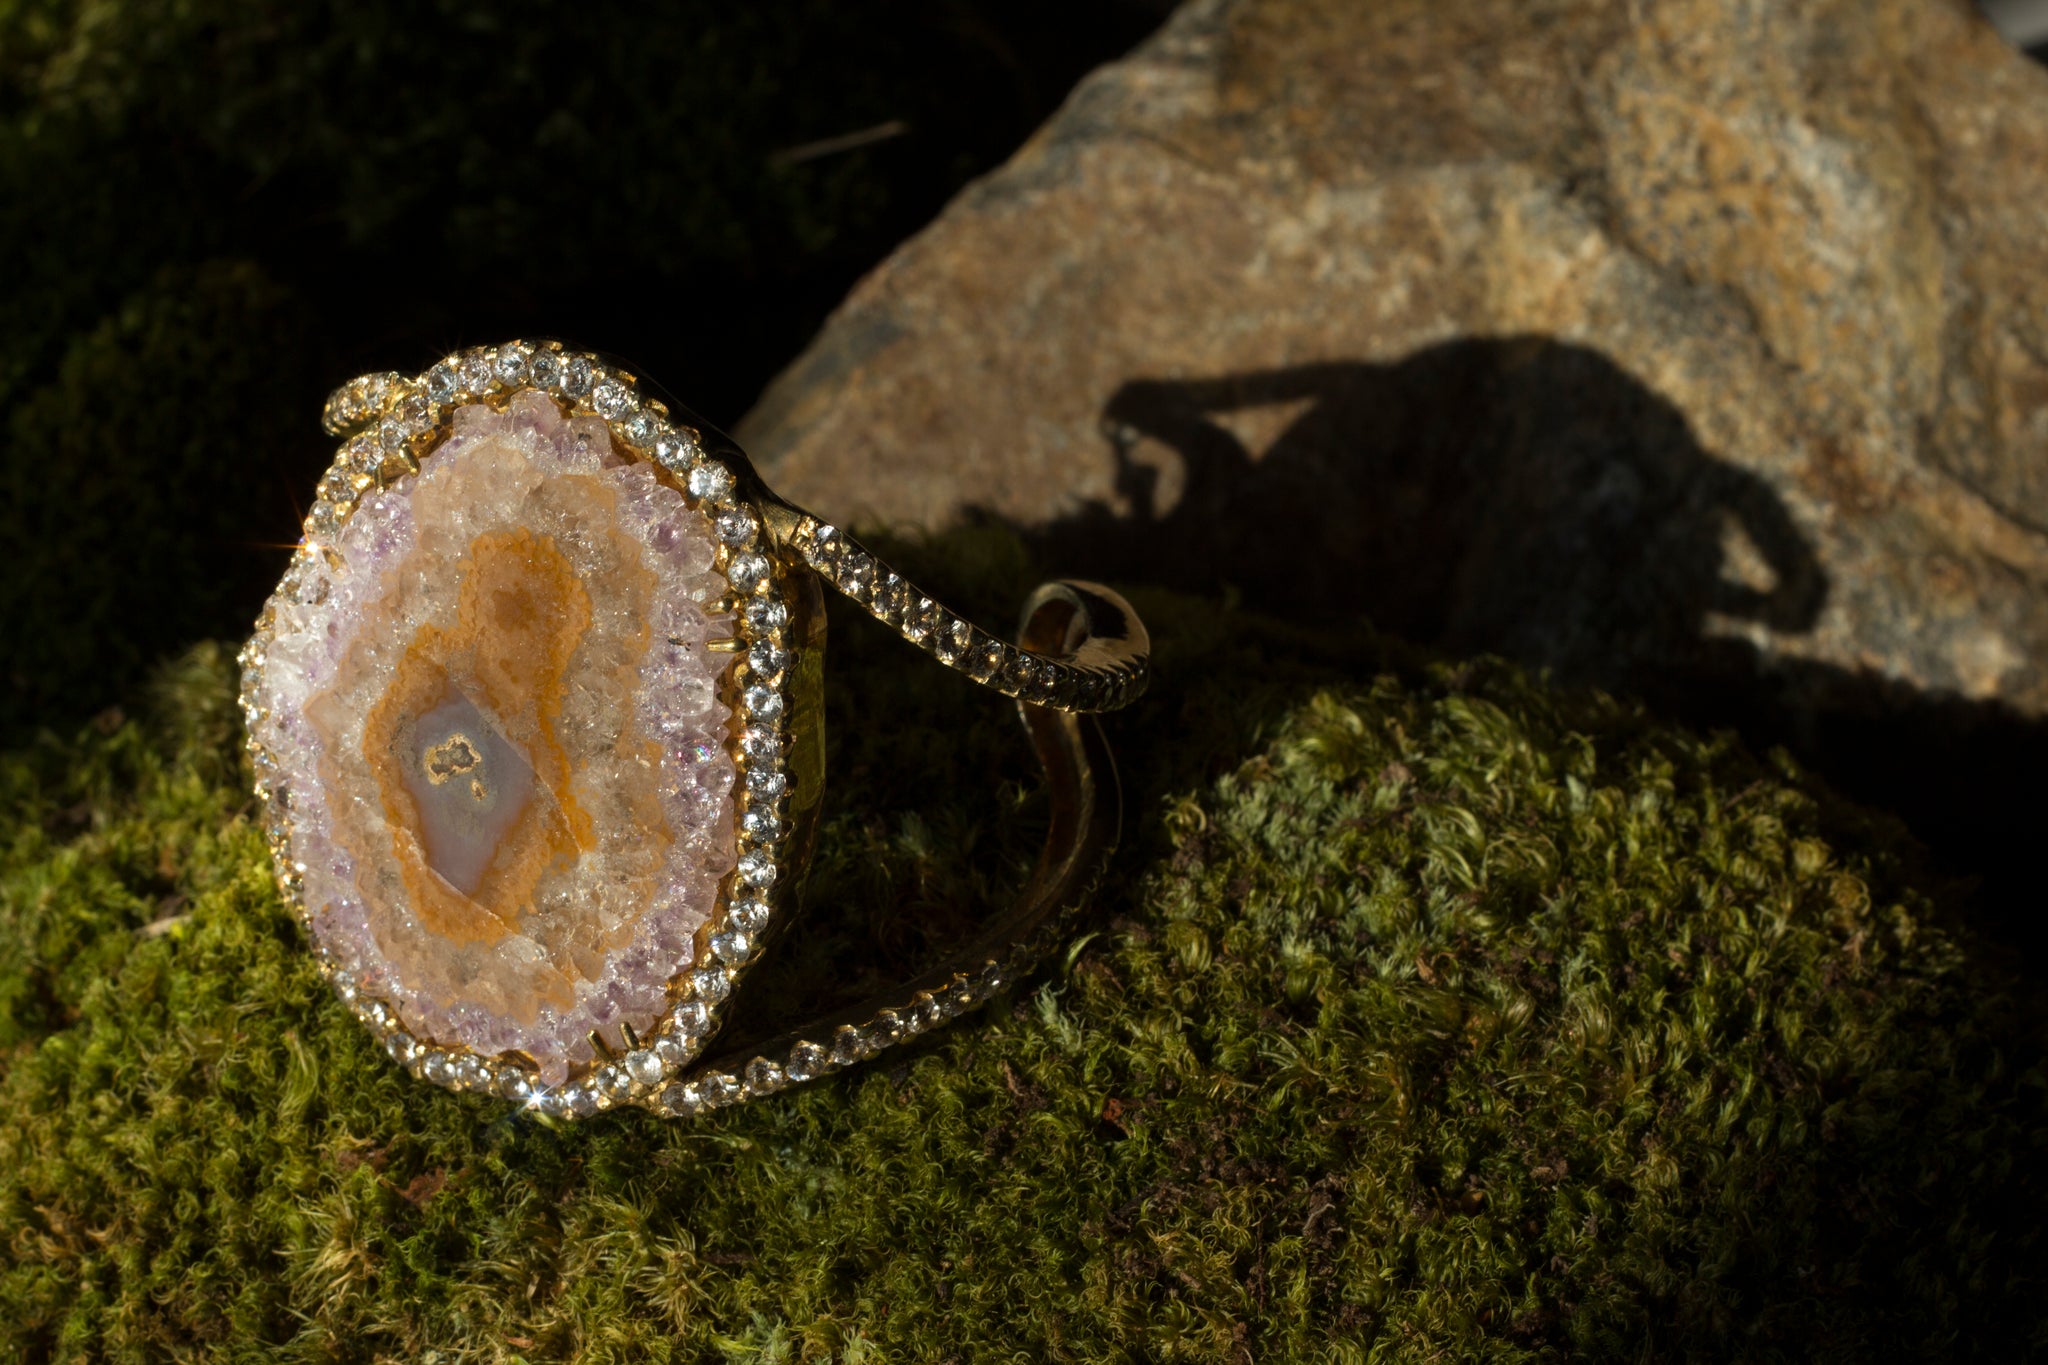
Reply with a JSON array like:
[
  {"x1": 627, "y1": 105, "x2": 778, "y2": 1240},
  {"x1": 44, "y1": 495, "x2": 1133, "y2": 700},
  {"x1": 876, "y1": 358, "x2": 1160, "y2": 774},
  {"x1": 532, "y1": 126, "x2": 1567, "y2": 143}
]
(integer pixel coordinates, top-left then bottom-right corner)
[{"x1": 0, "y1": 0, "x2": 1171, "y2": 745}]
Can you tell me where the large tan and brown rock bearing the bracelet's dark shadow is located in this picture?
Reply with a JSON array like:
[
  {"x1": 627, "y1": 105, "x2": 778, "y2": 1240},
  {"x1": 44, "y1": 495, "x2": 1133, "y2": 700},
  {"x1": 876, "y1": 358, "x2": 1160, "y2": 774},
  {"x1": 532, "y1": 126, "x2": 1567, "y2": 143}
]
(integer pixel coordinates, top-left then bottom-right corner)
[{"x1": 741, "y1": 0, "x2": 2048, "y2": 716}]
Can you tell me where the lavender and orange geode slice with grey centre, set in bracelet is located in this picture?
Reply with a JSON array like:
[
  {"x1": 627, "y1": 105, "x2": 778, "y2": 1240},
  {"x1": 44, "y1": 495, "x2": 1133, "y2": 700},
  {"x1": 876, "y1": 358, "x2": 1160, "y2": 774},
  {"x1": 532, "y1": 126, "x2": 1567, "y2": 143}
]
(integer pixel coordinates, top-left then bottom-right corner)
[{"x1": 254, "y1": 391, "x2": 733, "y2": 1085}]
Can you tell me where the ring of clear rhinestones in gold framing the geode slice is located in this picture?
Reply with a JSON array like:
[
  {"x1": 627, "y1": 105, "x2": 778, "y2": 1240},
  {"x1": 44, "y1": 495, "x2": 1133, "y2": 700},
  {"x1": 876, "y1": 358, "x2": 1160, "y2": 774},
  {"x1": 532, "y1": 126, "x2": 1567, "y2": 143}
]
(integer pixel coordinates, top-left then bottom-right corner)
[{"x1": 238, "y1": 342, "x2": 786, "y2": 1119}]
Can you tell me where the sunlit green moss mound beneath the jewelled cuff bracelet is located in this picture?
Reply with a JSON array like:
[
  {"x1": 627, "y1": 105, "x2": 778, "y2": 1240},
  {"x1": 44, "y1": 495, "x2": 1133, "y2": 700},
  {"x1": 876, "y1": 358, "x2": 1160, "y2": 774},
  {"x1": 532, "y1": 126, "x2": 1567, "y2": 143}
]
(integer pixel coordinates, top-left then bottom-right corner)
[{"x1": 0, "y1": 538, "x2": 2048, "y2": 1361}]
